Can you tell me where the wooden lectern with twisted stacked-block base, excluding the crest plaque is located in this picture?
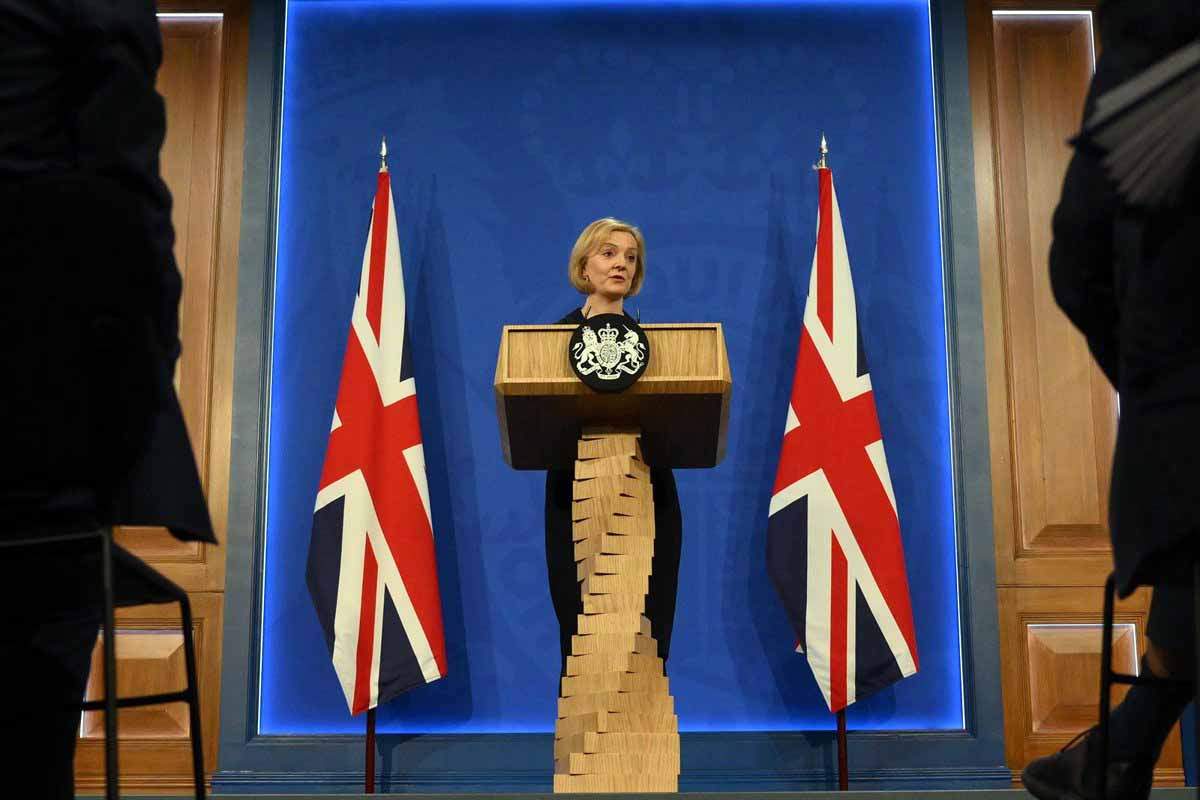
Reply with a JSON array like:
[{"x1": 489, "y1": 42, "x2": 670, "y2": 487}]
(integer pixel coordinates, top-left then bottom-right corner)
[{"x1": 496, "y1": 323, "x2": 733, "y2": 792}]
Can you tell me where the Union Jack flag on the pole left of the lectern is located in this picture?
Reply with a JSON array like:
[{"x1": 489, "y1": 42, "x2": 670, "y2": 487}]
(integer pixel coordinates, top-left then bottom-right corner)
[{"x1": 307, "y1": 167, "x2": 446, "y2": 714}]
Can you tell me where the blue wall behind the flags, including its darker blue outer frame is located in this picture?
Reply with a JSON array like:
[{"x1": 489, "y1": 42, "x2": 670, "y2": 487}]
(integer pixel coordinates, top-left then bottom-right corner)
[{"x1": 218, "y1": 0, "x2": 1010, "y2": 793}]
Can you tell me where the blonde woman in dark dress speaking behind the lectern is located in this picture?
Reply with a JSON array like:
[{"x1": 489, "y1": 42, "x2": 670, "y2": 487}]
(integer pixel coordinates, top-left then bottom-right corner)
[{"x1": 546, "y1": 217, "x2": 683, "y2": 675}]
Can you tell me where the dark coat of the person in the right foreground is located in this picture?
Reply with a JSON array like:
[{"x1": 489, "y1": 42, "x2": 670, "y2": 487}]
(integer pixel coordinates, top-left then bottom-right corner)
[{"x1": 1050, "y1": 0, "x2": 1200, "y2": 594}]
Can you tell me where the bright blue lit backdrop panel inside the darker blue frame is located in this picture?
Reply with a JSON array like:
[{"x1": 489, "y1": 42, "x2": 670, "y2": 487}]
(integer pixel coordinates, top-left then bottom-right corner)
[{"x1": 267, "y1": 0, "x2": 964, "y2": 734}]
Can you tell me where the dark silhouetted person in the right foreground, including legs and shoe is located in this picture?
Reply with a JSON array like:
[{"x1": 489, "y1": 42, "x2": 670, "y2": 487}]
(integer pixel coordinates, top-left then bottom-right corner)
[{"x1": 1022, "y1": 6, "x2": 1200, "y2": 800}]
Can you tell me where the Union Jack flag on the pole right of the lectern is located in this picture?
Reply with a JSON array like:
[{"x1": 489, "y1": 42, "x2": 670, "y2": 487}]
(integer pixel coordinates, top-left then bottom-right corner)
[{"x1": 767, "y1": 167, "x2": 917, "y2": 711}]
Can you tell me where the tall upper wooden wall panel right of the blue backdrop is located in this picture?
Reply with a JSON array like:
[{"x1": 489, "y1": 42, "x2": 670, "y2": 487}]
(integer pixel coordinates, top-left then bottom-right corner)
[{"x1": 968, "y1": 0, "x2": 1114, "y2": 585}]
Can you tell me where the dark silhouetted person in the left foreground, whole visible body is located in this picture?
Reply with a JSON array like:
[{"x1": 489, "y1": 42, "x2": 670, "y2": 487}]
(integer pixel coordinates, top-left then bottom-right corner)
[{"x1": 0, "y1": 0, "x2": 215, "y2": 798}]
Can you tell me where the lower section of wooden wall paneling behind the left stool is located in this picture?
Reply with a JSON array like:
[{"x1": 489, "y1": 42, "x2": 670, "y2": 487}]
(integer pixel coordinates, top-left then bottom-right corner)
[{"x1": 76, "y1": 591, "x2": 222, "y2": 794}]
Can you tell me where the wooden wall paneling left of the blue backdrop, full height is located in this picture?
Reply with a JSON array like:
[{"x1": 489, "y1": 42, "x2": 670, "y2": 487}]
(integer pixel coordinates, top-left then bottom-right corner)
[{"x1": 76, "y1": 0, "x2": 250, "y2": 792}]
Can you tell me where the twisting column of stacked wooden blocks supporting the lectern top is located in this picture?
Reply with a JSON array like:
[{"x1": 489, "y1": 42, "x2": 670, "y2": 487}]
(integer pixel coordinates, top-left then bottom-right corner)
[{"x1": 554, "y1": 429, "x2": 679, "y2": 792}]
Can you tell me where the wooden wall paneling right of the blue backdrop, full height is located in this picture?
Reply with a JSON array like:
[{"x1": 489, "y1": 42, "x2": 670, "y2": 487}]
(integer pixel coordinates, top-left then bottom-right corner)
[{"x1": 967, "y1": 0, "x2": 1182, "y2": 784}]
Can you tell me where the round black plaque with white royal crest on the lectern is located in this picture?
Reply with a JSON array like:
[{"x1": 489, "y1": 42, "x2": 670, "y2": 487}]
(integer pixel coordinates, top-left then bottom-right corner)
[{"x1": 566, "y1": 314, "x2": 650, "y2": 392}]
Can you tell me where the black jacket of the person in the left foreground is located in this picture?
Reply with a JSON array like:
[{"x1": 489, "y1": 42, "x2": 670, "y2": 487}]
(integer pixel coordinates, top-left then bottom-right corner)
[{"x1": 0, "y1": 0, "x2": 214, "y2": 541}]
